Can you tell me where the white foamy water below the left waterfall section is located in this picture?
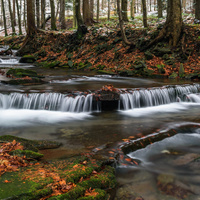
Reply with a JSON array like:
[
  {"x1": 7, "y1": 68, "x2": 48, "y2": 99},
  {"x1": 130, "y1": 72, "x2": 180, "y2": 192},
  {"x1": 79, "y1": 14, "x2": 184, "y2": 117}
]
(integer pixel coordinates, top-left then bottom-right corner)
[{"x1": 0, "y1": 109, "x2": 91, "y2": 127}]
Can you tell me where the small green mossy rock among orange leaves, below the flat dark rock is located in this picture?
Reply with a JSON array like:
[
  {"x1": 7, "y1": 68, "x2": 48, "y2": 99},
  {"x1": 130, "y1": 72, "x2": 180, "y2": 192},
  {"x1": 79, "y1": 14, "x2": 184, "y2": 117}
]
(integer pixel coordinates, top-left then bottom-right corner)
[{"x1": 9, "y1": 149, "x2": 44, "y2": 160}]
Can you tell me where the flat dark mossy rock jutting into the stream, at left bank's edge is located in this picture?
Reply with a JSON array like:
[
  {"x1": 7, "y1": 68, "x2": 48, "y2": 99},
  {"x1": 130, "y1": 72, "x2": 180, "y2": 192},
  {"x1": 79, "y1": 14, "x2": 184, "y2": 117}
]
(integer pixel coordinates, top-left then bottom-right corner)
[{"x1": 0, "y1": 135, "x2": 61, "y2": 152}]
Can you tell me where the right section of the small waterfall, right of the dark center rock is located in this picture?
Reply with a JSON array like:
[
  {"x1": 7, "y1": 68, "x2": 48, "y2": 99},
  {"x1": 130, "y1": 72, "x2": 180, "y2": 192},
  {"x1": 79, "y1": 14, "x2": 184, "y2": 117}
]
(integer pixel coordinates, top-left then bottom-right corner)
[{"x1": 119, "y1": 84, "x2": 200, "y2": 110}]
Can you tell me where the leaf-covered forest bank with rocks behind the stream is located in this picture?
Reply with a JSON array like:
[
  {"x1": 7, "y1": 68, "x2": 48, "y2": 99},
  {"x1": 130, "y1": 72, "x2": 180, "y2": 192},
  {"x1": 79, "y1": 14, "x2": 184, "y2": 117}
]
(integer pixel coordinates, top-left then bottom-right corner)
[{"x1": 1, "y1": 15, "x2": 200, "y2": 79}]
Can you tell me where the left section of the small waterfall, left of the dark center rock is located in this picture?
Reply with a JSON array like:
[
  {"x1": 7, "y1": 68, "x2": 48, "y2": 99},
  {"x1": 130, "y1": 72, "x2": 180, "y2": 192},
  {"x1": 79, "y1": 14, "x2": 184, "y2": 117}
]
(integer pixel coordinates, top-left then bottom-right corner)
[{"x1": 0, "y1": 93, "x2": 93, "y2": 112}]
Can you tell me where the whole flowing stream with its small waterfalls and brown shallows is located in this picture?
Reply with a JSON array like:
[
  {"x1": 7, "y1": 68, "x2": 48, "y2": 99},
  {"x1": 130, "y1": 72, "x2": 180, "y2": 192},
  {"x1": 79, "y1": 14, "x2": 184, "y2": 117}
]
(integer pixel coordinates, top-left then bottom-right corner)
[{"x1": 0, "y1": 58, "x2": 200, "y2": 200}]
